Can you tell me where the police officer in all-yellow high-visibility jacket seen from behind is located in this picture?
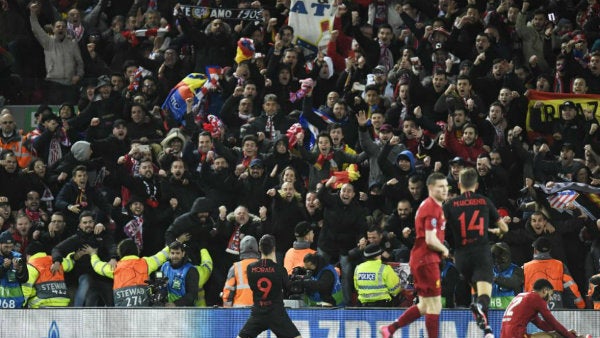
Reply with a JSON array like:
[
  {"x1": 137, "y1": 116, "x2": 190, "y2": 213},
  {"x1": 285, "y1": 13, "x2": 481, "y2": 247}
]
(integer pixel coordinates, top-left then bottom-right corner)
[{"x1": 354, "y1": 244, "x2": 401, "y2": 307}]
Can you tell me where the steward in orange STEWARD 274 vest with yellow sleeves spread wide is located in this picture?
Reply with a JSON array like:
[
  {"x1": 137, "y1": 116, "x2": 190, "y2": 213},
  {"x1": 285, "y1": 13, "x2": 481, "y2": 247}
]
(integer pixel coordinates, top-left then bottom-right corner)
[{"x1": 84, "y1": 238, "x2": 176, "y2": 307}]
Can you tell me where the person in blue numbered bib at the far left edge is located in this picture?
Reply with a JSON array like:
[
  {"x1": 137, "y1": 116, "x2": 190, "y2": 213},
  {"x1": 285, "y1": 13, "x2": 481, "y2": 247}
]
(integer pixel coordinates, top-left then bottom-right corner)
[{"x1": 0, "y1": 231, "x2": 29, "y2": 309}]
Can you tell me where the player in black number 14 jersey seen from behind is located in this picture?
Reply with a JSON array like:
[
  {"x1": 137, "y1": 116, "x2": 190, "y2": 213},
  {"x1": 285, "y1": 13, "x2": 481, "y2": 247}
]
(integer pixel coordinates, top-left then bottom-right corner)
[{"x1": 443, "y1": 168, "x2": 508, "y2": 337}]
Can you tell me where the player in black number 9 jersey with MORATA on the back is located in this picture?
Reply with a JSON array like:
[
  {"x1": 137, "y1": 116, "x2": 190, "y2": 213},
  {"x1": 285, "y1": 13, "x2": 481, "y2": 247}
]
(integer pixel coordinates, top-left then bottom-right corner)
[{"x1": 238, "y1": 235, "x2": 301, "y2": 338}]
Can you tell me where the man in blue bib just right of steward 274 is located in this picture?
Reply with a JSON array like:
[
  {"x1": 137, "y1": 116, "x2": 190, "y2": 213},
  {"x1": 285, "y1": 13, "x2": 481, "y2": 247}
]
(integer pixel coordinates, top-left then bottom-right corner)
[{"x1": 160, "y1": 241, "x2": 199, "y2": 307}]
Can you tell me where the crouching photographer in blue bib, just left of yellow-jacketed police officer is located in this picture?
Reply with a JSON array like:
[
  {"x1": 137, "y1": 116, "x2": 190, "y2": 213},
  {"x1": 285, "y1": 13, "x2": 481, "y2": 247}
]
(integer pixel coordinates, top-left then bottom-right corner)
[{"x1": 291, "y1": 253, "x2": 343, "y2": 306}]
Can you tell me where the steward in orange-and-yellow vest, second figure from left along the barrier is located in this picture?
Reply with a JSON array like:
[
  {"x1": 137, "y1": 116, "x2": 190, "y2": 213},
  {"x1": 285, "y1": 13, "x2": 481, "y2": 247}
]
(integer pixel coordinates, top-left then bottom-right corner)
[{"x1": 21, "y1": 241, "x2": 74, "y2": 309}]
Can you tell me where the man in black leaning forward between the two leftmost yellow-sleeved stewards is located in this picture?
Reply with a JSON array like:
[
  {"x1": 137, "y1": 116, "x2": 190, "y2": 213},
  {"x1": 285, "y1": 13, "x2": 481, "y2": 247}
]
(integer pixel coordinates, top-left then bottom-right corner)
[{"x1": 50, "y1": 211, "x2": 117, "y2": 307}]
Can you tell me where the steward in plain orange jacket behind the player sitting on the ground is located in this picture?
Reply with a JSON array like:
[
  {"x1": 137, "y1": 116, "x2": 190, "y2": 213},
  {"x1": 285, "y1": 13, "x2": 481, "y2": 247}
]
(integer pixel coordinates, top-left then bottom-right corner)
[{"x1": 523, "y1": 237, "x2": 585, "y2": 309}]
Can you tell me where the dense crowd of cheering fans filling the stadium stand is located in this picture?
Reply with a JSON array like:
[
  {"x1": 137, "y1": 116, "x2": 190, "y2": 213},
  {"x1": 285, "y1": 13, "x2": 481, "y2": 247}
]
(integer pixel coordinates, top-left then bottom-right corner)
[{"x1": 0, "y1": 0, "x2": 600, "y2": 308}]
